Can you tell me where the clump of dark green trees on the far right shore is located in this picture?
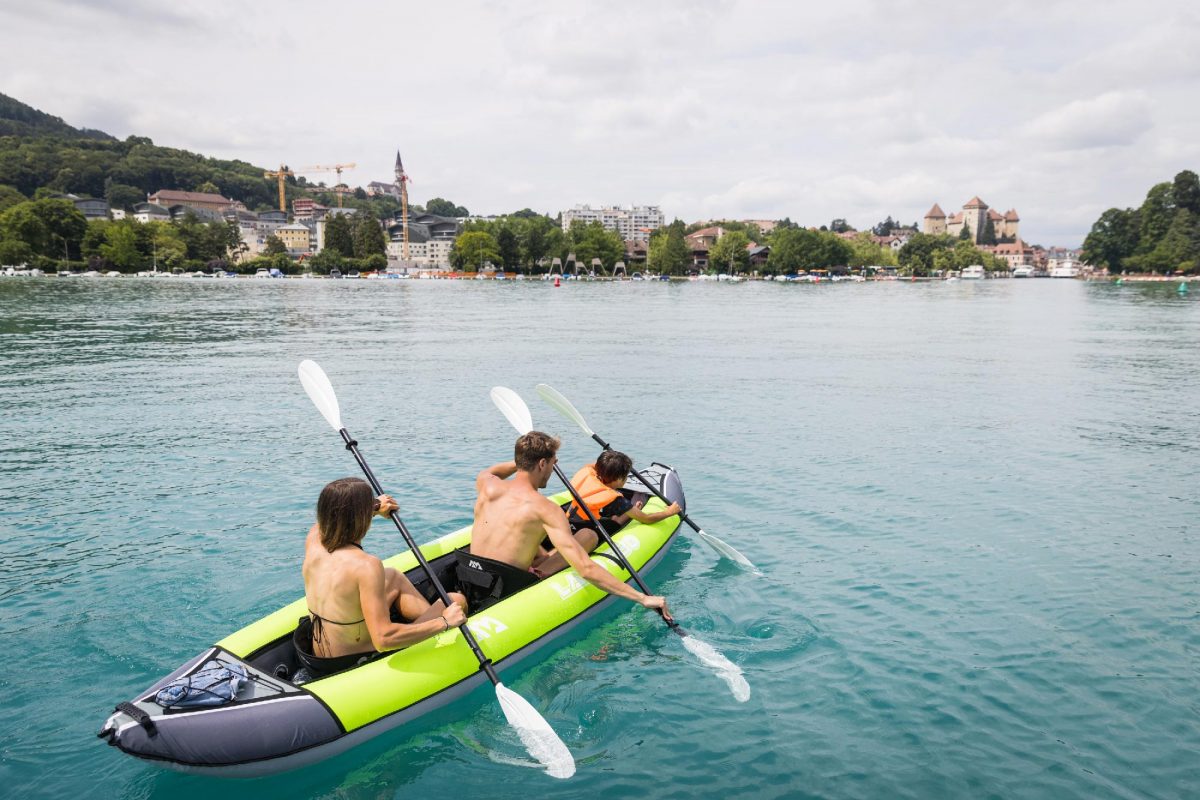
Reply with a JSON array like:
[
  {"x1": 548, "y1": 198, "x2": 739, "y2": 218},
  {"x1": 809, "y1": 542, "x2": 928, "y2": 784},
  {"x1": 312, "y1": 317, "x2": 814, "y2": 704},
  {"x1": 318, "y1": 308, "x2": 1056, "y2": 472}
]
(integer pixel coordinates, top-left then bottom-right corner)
[{"x1": 1082, "y1": 169, "x2": 1200, "y2": 273}]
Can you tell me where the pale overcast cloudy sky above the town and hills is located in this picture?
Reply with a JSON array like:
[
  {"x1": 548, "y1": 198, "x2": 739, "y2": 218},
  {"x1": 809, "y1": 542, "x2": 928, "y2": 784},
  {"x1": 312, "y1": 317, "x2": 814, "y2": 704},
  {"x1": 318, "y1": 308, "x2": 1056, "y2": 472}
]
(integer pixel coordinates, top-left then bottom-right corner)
[{"x1": 0, "y1": 0, "x2": 1200, "y2": 246}]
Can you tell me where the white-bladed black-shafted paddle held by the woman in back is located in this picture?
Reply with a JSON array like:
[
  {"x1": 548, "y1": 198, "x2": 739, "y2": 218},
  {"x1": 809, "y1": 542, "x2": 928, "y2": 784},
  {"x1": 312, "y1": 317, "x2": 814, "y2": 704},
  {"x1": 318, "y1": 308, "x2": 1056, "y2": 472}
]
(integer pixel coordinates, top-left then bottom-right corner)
[{"x1": 299, "y1": 360, "x2": 575, "y2": 778}]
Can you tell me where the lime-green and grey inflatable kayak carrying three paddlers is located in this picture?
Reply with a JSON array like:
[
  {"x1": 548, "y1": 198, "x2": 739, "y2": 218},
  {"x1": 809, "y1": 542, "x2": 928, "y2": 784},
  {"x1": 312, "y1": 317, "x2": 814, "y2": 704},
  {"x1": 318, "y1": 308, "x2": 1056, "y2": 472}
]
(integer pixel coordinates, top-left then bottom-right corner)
[{"x1": 97, "y1": 464, "x2": 684, "y2": 777}]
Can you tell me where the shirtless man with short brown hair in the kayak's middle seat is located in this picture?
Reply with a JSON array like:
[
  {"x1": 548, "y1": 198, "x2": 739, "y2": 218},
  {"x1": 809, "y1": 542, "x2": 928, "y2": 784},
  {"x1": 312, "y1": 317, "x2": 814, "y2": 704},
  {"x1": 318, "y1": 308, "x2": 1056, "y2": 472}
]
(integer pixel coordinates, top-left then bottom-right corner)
[{"x1": 458, "y1": 431, "x2": 672, "y2": 620}]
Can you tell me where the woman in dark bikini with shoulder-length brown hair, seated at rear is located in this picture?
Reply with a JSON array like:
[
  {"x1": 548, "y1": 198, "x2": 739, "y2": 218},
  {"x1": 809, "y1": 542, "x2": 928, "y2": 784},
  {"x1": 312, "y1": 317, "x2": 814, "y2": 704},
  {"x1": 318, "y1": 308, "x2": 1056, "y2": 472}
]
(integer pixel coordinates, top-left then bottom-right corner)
[{"x1": 304, "y1": 477, "x2": 467, "y2": 672}]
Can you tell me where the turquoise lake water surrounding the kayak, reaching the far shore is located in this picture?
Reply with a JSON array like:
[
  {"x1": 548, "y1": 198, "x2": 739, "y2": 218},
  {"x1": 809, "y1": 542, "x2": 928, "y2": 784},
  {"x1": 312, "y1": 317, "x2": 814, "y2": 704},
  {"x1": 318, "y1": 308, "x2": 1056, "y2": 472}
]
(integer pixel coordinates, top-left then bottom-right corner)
[{"x1": 0, "y1": 278, "x2": 1200, "y2": 799}]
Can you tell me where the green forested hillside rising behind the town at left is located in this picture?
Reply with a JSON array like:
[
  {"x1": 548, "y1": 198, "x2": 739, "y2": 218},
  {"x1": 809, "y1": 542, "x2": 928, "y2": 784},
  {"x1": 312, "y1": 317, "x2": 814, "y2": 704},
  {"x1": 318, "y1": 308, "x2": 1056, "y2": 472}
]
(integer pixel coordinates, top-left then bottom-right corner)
[{"x1": 0, "y1": 95, "x2": 388, "y2": 216}]
